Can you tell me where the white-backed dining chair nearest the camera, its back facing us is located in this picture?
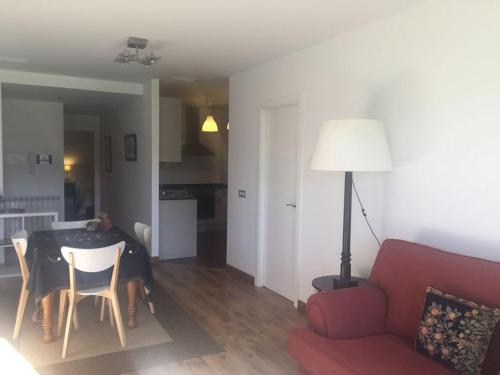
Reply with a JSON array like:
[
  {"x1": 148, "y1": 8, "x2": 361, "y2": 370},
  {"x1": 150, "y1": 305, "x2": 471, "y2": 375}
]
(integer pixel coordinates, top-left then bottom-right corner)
[{"x1": 61, "y1": 241, "x2": 126, "y2": 359}]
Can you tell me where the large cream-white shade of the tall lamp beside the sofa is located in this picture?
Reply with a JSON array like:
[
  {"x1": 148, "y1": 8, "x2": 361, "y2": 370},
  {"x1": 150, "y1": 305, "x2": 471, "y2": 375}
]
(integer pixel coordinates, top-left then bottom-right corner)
[{"x1": 310, "y1": 119, "x2": 392, "y2": 172}]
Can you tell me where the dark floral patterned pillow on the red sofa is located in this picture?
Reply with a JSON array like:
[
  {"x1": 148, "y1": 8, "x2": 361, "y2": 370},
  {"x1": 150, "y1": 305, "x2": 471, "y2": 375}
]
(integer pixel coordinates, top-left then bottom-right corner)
[{"x1": 416, "y1": 287, "x2": 500, "y2": 375}]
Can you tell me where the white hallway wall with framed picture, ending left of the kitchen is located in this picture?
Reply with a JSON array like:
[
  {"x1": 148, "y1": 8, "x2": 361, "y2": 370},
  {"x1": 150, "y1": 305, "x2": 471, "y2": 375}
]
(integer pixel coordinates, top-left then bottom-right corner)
[{"x1": 101, "y1": 80, "x2": 159, "y2": 256}]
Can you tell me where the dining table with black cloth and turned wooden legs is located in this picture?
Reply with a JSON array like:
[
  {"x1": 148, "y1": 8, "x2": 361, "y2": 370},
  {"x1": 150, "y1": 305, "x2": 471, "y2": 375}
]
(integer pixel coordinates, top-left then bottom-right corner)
[{"x1": 25, "y1": 227, "x2": 153, "y2": 343}]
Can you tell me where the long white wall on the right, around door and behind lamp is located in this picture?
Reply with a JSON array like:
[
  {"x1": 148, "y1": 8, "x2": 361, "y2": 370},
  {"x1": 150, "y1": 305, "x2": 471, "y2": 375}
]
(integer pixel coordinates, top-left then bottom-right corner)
[{"x1": 228, "y1": 0, "x2": 500, "y2": 300}]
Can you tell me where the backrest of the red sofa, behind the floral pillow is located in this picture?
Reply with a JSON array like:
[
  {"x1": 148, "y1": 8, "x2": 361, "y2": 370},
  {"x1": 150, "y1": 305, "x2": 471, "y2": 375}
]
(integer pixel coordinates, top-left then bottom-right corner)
[{"x1": 370, "y1": 240, "x2": 500, "y2": 374}]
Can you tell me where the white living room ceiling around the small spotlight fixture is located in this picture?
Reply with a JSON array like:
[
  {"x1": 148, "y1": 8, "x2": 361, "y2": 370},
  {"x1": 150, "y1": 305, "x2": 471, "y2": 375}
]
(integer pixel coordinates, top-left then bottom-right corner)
[{"x1": 0, "y1": 0, "x2": 422, "y2": 86}]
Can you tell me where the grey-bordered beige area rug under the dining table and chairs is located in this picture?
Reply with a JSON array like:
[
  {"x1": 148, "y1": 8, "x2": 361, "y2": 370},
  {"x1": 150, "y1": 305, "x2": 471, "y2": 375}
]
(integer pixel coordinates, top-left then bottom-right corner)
[{"x1": 0, "y1": 285, "x2": 222, "y2": 375}]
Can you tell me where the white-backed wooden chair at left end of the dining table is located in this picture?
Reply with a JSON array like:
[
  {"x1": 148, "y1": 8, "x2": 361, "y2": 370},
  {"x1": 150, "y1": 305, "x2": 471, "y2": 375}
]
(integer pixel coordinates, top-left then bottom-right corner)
[{"x1": 11, "y1": 230, "x2": 30, "y2": 339}]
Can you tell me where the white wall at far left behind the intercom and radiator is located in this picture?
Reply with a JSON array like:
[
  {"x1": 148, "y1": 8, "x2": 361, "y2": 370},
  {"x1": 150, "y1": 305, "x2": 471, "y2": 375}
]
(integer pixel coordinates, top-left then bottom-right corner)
[{"x1": 2, "y1": 98, "x2": 64, "y2": 217}]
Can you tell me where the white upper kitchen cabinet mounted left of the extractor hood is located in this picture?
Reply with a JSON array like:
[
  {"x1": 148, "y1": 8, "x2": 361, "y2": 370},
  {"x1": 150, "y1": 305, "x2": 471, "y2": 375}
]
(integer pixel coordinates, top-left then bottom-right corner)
[{"x1": 160, "y1": 97, "x2": 182, "y2": 162}]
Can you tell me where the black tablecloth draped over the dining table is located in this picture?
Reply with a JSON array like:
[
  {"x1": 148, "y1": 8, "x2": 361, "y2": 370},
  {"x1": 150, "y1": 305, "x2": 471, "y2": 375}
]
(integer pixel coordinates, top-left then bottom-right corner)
[{"x1": 26, "y1": 228, "x2": 153, "y2": 302}]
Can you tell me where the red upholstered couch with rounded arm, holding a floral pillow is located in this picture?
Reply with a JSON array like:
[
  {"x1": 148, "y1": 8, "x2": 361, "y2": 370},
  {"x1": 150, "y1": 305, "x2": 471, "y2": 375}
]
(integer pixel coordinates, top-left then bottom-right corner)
[{"x1": 288, "y1": 240, "x2": 500, "y2": 375}]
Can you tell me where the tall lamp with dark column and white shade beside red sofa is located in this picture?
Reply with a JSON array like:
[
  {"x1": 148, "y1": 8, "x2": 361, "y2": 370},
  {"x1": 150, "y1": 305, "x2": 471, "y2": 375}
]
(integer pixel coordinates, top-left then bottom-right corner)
[{"x1": 310, "y1": 119, "x2": 392, "y2": 289}]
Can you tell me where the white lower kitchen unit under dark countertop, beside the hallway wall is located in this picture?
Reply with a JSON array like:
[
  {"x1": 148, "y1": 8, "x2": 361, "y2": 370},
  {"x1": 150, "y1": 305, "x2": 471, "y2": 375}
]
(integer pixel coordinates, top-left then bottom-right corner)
[{"x1": 160, "y1": 199, "x2": 198, "y2": 260}]
